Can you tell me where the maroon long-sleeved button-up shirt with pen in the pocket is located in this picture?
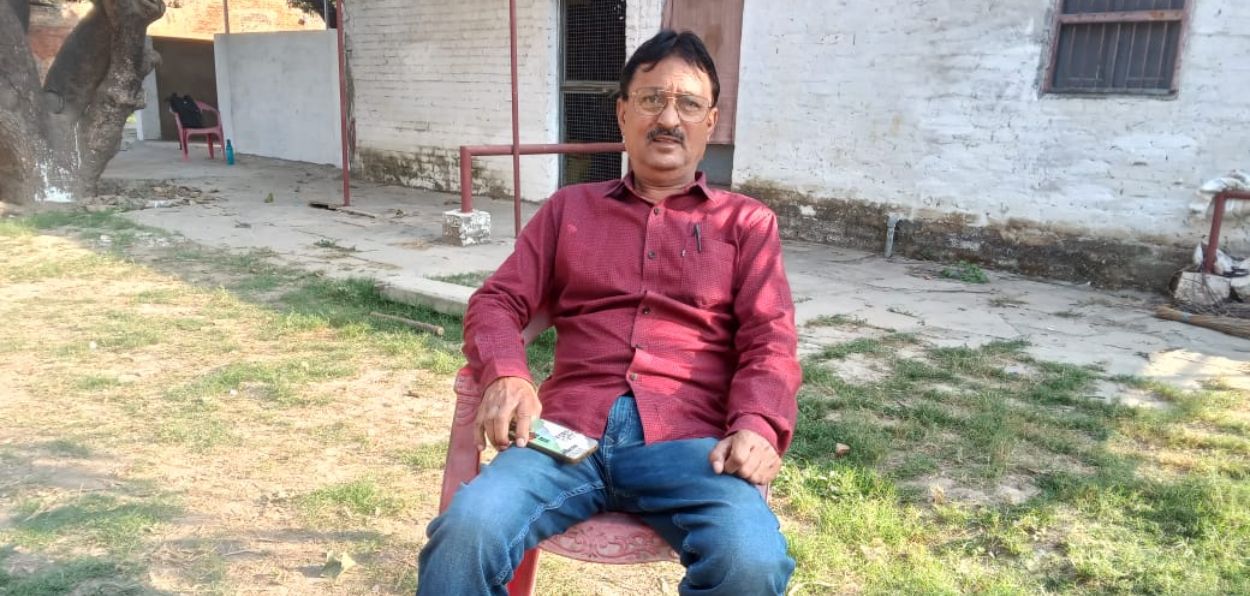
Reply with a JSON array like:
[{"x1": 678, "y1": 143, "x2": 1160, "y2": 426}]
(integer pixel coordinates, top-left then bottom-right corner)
[{"x1": 464, "y1": 174, "x2": 801, "y2": 454}]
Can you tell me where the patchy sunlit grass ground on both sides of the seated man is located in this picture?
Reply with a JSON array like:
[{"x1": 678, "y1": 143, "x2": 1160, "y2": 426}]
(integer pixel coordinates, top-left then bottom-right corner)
[{"x1": 0, "y1": 206, "x2": 1250, "y2": 595}]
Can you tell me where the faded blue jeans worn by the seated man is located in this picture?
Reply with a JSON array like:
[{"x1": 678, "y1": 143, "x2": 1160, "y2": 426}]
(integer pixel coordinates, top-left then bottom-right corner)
[{"x1": 416, "y1": 396, "x2": 794, "y2": 596}]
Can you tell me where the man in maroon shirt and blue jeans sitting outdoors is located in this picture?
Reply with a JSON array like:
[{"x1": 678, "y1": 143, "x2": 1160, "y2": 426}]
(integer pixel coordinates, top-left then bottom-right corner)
[{"x1": 418, "y1": 31, "x2": 800, "y2": 596}]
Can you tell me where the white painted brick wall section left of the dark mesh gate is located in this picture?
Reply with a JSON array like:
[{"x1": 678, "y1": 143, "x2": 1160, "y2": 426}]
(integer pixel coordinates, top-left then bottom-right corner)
[{"x1": 346, "y1": 0, "x2": 560, "y2": 200}]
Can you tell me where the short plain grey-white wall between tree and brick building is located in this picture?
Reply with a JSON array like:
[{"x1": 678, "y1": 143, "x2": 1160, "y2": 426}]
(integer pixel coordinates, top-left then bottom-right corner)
[{"x1": 213, "y1": 30, "x2": 343, "y2": 165}]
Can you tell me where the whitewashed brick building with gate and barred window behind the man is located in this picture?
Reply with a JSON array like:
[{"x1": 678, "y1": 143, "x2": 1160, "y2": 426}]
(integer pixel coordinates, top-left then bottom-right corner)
[{"x1": 348, "y1": 0, "x2": 1250, "y2": 286}]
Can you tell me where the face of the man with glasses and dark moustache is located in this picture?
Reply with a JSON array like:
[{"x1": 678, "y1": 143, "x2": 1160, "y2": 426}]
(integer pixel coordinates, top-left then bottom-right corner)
[{"x1": 616, "y1": 56, "x2": 719, "y2": 180}]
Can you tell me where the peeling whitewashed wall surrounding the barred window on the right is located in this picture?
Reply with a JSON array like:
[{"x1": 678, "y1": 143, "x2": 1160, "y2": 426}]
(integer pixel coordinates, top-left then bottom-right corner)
[{"x1": 734, "y1": 0, "x2": 1250, "y2": 241}]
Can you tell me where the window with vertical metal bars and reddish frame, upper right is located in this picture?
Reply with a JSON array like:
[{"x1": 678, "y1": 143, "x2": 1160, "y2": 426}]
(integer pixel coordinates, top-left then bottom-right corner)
[{"x1": 1045, "y1": 0, "x2": 1188, "y2": 95}]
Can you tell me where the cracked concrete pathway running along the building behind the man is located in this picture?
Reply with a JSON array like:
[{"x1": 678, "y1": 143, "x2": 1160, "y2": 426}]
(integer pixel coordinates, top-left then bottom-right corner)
[{"x1": 105, "y1": 142, "x2": 1250, "y2": 390}]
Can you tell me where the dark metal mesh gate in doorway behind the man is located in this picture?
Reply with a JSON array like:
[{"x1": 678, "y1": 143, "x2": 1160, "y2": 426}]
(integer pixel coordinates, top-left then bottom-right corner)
[{"x1": 560, "y1": 0, "x2": 625, "y2": 186}]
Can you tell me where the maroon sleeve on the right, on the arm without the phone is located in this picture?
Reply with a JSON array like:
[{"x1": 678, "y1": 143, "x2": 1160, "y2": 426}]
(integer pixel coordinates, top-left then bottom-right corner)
[{"x1": 728, "y1": 207, "x2": 803, "y2": 454}]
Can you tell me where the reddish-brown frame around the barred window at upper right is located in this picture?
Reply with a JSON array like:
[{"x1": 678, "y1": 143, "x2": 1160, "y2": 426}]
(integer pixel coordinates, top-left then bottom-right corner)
[{"x1": 1041, "y1": 0, "x2": 1196, "y2": 99}]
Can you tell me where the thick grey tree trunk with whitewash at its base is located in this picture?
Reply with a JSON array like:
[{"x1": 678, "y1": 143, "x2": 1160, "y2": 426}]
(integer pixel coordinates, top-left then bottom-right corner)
[{"x1": 0, "y1": 0, "x2": 165, "y2": 204}]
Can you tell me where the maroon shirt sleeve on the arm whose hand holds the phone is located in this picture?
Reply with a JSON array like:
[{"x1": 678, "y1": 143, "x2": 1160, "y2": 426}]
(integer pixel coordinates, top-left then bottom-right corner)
[{"x1": 464, "y1": 194, "x2": 561, "y2": 389}]
